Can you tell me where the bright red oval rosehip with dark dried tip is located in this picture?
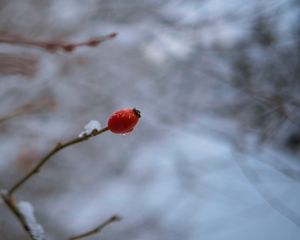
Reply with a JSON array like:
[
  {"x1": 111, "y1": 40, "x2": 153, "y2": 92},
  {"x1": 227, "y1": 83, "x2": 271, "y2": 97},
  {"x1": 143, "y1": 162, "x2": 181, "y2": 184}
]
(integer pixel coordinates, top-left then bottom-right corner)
[{"x1": 107, "y1": 108, "x2": 141, "y2": 134}]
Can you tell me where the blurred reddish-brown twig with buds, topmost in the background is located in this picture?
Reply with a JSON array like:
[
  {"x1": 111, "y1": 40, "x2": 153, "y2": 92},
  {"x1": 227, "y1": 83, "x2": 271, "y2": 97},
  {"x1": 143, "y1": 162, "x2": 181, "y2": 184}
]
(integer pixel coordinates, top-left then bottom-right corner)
[{"x1": 0, "y1": 33, "x2": 117, "y2": 52}]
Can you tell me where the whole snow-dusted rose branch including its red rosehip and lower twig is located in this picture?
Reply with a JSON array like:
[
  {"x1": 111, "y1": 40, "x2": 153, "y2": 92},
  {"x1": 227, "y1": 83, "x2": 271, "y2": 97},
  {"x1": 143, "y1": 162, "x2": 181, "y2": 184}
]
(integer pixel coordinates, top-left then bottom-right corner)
[{"x1": 1, "y1": 108, "x2": 140, "y2": 240}]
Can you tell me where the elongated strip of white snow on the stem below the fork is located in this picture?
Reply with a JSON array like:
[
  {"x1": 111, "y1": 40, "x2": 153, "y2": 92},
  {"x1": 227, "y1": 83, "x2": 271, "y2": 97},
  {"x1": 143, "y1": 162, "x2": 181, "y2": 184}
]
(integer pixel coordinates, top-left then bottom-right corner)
[{"x1": 17, "y1": 201, "x2": 46, "y2": 240}]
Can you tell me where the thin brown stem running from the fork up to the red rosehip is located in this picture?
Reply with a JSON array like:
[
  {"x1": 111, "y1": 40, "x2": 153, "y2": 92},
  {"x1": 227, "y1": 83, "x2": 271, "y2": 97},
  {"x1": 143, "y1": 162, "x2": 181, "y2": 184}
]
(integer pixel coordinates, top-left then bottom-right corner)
[{"x1": 8, "y1": 127, "x2": 108, "y2": 197}]
